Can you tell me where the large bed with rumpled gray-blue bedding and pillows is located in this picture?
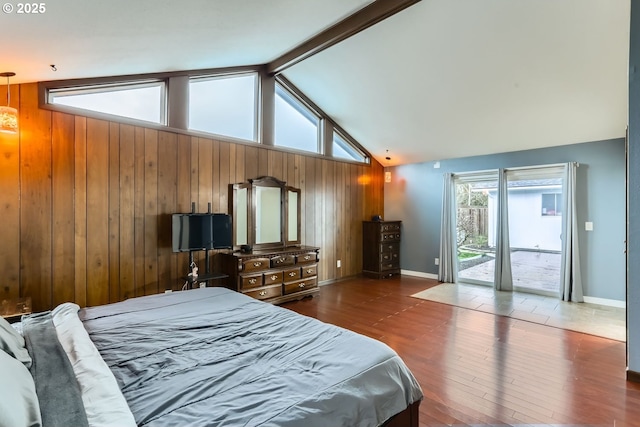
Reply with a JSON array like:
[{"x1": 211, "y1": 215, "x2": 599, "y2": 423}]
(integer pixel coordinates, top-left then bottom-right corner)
[{"x1": 0, "y1": 288, "x2": 422, "y2": 427}]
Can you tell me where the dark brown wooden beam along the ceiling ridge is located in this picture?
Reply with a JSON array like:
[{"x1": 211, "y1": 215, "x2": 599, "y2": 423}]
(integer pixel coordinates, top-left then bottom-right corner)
[{"x1": 267, "y1": 0, "x2": 420, "y2": 75}]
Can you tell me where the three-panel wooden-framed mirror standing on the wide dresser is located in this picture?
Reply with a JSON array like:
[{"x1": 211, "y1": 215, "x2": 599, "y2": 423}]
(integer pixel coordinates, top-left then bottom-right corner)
[{"x1": 229, "y1": 176, "x2": 301, "y2": 249}]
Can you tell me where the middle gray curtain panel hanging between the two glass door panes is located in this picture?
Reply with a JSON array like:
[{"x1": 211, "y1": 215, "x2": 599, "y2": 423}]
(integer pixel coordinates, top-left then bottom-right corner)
[{"x1": 494, "y1": 169, "x2": 513, "y2": 291}]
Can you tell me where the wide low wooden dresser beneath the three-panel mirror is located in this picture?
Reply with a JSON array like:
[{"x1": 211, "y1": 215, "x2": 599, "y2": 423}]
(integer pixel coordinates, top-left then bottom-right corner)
[{"x1": 218, "y1": 246, "x2": 320, "y2": 304}]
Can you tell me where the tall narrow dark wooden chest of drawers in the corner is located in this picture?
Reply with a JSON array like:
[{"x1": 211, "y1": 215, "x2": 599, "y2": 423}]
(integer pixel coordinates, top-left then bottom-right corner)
[{"x1": 362, "y1": 221, "x2": 402, "y2": 279}]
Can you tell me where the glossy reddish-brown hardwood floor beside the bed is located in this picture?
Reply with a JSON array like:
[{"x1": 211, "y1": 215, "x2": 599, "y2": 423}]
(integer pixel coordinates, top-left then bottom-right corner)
[{"x1": 283, "y1": 276, "x2": 640, "y2": 427}]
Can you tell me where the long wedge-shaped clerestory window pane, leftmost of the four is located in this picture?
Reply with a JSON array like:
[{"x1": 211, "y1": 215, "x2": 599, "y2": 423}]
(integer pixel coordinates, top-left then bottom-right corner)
[{"x1": 49, "y1": 81, "x2": 165, "y2": 124}]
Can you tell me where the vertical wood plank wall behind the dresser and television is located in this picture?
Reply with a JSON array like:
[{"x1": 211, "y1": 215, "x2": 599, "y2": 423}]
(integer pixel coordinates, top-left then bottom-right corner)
[{"x1": 0, "y1": 83, "x2": 384, "y2": 311}]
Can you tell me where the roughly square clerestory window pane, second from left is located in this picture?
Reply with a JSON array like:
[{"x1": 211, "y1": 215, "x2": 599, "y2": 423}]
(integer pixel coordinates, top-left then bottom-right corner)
[{"x1": 189, "y1": 73, "x2": 257, "y2": 141}]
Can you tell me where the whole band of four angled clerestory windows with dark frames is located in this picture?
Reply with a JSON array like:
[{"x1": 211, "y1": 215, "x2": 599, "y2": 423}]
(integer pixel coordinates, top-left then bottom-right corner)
[{"x1": 40, "y1": 67, "x2": 370, "y2": 163}]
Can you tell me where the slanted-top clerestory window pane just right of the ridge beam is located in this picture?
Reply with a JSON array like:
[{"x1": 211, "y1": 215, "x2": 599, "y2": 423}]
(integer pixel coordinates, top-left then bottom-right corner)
[{"x1": 275, "y1": 84, "x2": 320, "y2": 153}]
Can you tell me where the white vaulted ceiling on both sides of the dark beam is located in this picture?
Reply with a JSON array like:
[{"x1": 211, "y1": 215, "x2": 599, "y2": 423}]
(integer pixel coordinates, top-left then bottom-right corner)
[{"x1": 0, "y1": 0, "x2": 630, "y2": 165}]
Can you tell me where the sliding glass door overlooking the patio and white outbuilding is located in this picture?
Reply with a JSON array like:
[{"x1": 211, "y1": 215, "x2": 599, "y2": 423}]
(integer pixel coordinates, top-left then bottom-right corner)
[{"x1": 454, "y1": 166, "x2": 564, "y2": 296}]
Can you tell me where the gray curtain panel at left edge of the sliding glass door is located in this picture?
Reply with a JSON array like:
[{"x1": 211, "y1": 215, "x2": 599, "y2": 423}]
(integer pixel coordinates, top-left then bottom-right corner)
[{"x1": 438, "y1": 173, "x2": 458, "y2": 283}]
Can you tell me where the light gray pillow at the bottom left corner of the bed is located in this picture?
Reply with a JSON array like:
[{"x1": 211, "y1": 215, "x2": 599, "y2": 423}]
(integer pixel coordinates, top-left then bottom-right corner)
[{"x1": 0, "y1": 351, "x2": 42, "y2": 427}]
